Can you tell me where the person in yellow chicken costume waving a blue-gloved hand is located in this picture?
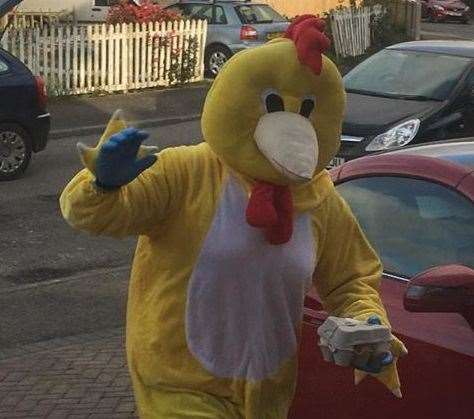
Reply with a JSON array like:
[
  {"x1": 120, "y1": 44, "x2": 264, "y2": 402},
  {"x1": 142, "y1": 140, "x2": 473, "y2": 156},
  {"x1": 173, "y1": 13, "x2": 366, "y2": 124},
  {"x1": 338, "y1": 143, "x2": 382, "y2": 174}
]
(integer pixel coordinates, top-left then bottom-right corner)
[{"x1": 60, "y1": 16, "x2": 406, "y2": 419}]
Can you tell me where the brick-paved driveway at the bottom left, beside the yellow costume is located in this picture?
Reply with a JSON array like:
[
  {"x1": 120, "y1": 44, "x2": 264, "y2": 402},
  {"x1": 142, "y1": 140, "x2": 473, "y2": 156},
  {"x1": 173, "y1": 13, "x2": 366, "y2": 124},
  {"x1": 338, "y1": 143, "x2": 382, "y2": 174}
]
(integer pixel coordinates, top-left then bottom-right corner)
[{"x1": 0, "y1": 328, "x2": 138, "y2": 419}]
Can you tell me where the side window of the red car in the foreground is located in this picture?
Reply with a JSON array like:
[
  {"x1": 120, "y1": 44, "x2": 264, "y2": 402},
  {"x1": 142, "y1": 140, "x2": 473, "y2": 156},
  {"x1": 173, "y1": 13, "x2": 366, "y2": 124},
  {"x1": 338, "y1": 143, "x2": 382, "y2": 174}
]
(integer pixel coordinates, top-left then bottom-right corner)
[{"x1": 337, "y1": 177, "x2": 474, "y2": 278}]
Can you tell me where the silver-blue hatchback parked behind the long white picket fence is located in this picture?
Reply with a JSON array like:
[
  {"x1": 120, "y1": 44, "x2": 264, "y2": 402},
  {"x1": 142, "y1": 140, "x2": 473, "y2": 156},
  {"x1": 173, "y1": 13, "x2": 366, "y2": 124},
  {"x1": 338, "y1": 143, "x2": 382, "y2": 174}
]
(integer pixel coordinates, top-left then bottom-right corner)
[{"x1": 167, "y1": 0, "x2": 290, "y2": 77}]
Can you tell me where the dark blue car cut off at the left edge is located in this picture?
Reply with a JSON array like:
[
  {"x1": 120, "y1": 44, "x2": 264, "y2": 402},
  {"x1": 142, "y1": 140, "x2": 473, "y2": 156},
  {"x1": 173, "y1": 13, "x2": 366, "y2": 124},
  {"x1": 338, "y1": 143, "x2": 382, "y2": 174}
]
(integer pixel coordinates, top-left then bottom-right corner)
[{"x1": 0, "y1": 0, "x2": 50, "y2": 181}]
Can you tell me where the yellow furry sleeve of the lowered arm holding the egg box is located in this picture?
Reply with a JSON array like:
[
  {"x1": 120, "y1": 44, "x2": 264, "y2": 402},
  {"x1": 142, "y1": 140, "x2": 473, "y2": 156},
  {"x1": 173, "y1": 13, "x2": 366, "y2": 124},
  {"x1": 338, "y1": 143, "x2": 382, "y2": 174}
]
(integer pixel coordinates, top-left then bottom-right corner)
[{"x1": 314, "y1": 190, "x2": 388, "y2": 324}]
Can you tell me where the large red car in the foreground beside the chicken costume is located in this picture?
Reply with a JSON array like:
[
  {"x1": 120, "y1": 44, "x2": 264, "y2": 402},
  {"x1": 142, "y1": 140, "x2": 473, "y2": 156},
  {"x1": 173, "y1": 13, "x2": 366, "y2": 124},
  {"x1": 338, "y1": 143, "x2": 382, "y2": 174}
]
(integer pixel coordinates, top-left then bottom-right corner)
[{"x1": 289, "y1": 138, "x2": 474, "y2": 419}]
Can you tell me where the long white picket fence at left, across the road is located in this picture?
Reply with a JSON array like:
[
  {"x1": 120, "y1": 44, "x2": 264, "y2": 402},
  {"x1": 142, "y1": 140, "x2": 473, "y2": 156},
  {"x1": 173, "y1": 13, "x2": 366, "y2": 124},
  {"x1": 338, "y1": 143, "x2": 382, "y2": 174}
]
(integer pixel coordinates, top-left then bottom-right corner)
[{"x1": 1, "y1": 20, "x2": 207, "y2": 95}]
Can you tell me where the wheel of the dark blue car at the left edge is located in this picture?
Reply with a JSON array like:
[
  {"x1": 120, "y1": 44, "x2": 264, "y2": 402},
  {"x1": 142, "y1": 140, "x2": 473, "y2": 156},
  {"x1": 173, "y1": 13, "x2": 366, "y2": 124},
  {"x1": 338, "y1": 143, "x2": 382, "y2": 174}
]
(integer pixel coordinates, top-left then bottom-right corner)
[{"x1": 0, "y1": 124, "x2": 31, "y2": 181}]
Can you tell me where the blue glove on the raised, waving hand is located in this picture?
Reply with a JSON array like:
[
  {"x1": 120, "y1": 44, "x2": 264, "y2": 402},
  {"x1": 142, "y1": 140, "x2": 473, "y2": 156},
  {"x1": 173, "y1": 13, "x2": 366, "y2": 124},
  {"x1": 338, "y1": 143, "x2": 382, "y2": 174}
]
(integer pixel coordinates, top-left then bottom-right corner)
[{"x1": 95, "y1": 128, "x2": 156, "y2": 189}]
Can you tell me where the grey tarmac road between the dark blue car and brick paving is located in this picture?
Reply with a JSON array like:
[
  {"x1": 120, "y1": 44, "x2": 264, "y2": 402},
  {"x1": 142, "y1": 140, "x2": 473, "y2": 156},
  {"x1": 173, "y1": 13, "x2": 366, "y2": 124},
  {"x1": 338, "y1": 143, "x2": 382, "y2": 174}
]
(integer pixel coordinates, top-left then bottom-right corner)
[{"x1": 0, "y1": 121, "x2": 201, "y2": 350}]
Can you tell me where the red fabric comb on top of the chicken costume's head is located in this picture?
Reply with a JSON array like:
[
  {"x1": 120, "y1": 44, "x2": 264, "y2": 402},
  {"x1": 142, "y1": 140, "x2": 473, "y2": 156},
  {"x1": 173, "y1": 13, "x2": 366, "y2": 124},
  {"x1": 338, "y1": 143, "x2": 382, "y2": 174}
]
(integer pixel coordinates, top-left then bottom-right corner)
[{"x1": 285, "y1": 15, "x2": 331, "y2": 75}]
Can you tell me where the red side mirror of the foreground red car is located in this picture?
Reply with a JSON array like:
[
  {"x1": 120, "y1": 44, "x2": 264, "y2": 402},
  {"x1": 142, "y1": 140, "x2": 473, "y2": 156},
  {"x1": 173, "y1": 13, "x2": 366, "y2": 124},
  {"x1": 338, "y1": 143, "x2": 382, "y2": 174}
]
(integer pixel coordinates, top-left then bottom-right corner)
[{"x1": 403, "y1": 265, "x2": 474, "y2": 329}]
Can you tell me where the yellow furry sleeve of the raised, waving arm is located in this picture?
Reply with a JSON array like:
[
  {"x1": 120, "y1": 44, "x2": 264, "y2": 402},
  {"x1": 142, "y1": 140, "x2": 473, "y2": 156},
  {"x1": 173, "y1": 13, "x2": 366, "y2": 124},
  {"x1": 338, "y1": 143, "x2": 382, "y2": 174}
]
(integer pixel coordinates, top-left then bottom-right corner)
[{"x1": 60, "y1": 149, "x2": 183, "y2": 238}]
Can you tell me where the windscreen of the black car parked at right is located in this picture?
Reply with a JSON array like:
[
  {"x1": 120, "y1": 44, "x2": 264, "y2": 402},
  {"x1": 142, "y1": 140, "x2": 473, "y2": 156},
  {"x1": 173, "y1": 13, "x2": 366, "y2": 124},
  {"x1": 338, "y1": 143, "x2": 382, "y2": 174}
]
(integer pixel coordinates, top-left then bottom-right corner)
[{"x1": 344, "y1": 49, "x2": 471, "y2": 100}]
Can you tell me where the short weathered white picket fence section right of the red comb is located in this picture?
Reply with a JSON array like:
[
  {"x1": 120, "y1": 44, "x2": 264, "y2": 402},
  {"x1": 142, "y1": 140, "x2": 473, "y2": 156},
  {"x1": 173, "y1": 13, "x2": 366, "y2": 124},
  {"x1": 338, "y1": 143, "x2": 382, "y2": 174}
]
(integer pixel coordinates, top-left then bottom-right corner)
[{"x1": 330, "y1": 7, "x2": 374, "y2": 57}]
